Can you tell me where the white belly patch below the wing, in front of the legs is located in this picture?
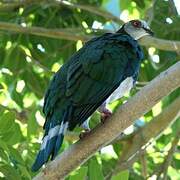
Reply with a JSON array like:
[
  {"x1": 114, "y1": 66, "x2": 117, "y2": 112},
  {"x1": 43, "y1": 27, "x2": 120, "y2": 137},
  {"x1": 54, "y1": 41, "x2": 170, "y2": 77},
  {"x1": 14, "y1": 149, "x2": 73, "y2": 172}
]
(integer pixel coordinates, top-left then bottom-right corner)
[{"x1": 106, "y1": 77, "x2": 133, "y2": 104}]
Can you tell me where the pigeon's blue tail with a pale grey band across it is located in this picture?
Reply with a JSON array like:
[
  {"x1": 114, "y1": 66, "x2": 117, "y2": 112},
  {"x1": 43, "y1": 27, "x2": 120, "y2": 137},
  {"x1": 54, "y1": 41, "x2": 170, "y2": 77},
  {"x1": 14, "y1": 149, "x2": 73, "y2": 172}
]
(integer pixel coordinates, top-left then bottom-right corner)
[{"x1": 32, "y1": 107, "x2": 69, "y2": 171}]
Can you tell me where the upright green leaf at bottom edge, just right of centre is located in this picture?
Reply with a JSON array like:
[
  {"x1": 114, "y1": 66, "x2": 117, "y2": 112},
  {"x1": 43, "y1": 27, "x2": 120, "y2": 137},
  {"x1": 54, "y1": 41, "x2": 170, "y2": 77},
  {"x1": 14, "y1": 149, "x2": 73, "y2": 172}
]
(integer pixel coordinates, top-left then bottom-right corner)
[{"x1": 88, "y1": 157, "x2": 104, "y2": 180}]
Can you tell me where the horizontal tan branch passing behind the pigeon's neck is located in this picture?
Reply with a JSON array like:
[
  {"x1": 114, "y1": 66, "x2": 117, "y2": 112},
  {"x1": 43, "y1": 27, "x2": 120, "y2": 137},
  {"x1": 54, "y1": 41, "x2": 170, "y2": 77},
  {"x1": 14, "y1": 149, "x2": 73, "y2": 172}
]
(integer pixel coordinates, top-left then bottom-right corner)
[{"x1": 0, "y1": 21, "x2": 180, "y2": 52}]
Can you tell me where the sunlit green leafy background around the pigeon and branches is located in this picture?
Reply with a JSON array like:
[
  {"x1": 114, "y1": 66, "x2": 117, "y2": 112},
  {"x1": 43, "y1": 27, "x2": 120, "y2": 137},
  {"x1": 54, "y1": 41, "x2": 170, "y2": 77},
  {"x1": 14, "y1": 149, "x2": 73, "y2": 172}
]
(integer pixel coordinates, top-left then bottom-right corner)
[{"x1": 0, "y1": 0, "x2": 180, "y2": 180}]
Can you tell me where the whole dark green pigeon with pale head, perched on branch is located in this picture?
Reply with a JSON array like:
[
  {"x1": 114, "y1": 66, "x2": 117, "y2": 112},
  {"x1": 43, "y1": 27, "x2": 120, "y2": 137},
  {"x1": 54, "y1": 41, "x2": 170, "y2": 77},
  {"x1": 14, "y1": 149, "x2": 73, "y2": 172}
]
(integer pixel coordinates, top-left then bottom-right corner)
[{"x1": 32, "y1": 20, "x2": 153, "y2": 171}]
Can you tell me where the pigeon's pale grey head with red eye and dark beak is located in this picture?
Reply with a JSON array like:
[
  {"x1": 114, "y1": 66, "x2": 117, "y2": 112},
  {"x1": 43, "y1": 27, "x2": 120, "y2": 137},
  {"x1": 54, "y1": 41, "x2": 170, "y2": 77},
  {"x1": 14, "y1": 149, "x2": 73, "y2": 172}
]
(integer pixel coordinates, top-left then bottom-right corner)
[{"x1": 117, "y1": 20, "x2": 153, "y2": 40}]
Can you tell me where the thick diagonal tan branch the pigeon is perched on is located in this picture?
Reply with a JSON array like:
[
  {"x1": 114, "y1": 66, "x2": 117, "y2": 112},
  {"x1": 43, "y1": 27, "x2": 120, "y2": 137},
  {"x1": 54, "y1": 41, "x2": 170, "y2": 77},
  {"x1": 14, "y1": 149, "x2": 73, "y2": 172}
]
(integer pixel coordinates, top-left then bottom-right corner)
[{"x1": 34, "y1": 62, "x2": 180, "y2": 180}]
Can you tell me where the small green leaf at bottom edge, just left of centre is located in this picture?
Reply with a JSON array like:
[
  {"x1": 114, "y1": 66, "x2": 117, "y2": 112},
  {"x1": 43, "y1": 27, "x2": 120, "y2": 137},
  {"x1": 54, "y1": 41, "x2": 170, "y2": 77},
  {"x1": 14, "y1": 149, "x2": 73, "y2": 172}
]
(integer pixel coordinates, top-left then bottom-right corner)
[{"x1": 69, "y1": 166, "x2": 88, "y2": 180}]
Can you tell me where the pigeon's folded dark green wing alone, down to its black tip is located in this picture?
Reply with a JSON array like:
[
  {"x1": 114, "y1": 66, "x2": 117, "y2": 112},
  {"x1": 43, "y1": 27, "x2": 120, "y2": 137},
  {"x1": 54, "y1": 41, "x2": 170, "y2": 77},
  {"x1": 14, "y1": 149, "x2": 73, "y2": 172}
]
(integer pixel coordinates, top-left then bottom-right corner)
[{"x1": 65, "y1": 33, "x2": 137, "y2": 130}]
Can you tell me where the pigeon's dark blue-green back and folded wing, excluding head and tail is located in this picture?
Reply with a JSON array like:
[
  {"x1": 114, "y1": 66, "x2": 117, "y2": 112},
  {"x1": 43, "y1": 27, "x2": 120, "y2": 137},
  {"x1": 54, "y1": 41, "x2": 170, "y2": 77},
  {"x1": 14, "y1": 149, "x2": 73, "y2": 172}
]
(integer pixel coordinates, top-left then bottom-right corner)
[{"x1": 44, "y1": 34, "x2": 141, "y2": 129}]
